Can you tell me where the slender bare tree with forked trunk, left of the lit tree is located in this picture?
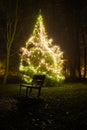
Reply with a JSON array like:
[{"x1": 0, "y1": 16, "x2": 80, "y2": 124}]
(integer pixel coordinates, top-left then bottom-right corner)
[{"x1": 3, "y1": 0, "x2": 18, "y2": 83}]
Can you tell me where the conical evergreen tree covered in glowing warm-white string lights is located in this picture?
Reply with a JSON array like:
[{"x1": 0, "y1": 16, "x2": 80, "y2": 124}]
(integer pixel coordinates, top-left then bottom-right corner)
[{"x1": 19, "y1": 14, "x2": 65, "y2": 85}]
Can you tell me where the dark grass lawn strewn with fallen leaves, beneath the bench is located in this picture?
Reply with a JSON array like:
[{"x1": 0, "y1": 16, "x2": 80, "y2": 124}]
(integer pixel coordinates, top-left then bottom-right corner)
[{"x1": 0, "y1": 83, "x2": 87, "y2": 130}]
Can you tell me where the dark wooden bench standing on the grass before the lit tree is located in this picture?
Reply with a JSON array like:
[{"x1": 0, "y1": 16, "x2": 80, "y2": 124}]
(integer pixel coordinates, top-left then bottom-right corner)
[{"x1": 19, "y1": 75, "x2": 45, "y2": 98}]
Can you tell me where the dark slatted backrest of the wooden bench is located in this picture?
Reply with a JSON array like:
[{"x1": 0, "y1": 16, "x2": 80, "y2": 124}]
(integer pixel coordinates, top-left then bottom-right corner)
[{"x1": 32, "y1": 75, "x2": 45, "y2": 87}]
